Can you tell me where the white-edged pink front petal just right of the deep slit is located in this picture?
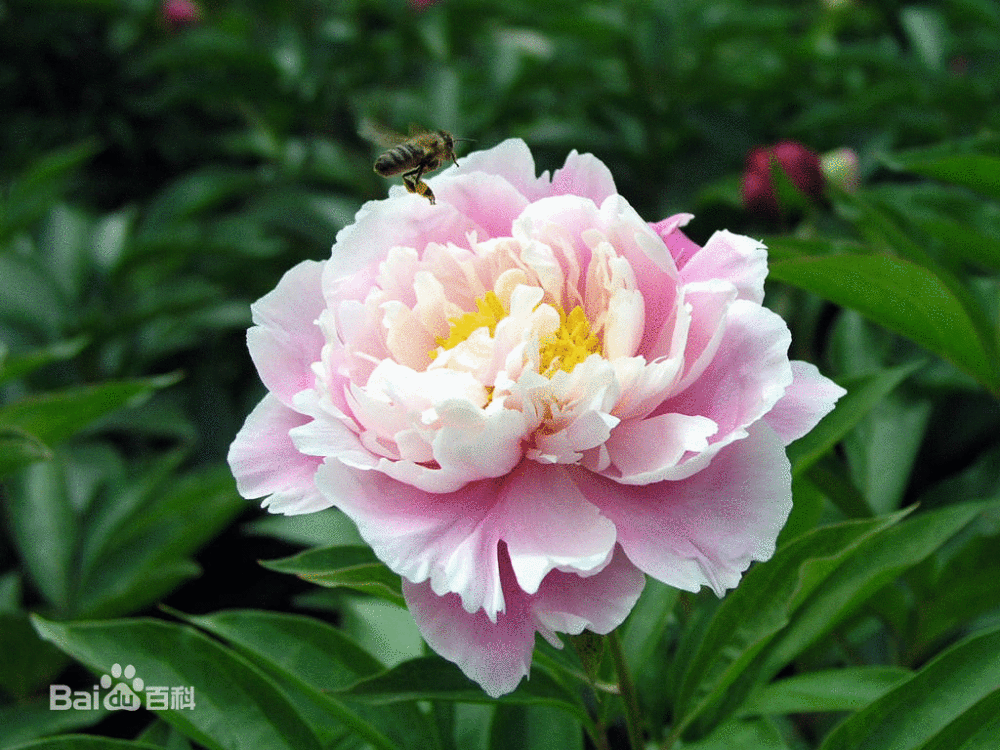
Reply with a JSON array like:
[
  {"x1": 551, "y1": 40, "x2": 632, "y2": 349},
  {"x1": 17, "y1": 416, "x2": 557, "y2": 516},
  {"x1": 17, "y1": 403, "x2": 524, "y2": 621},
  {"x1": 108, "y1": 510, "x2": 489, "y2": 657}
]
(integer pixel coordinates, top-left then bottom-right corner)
[{"x1": 496, "y1": 461, "x2": 615, "y2": 594}]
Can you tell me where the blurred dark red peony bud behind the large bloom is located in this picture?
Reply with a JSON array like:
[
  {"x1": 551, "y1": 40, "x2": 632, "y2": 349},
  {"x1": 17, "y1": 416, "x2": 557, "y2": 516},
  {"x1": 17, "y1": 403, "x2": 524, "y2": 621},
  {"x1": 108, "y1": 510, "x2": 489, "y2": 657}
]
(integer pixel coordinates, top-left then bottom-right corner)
[{"x1": 742, "y1": 141, "x2": 825, "y2": 219}]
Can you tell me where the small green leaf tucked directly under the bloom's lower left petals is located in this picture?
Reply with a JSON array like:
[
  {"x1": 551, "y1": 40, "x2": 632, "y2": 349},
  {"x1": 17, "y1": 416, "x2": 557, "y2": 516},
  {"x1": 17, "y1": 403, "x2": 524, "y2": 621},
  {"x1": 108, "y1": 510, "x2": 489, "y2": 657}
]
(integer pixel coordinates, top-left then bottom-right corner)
[{"x1": 261, "y1": 546, "x2": 406, "y2": 607}]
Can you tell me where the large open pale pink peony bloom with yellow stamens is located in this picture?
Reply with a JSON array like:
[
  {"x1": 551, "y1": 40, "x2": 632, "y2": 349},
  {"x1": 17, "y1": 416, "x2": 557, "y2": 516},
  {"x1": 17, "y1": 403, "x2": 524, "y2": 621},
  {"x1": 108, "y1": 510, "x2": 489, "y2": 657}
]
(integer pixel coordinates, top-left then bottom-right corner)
[{"x1": 229, "y1": 140, "x2": 844, "y2": 696}]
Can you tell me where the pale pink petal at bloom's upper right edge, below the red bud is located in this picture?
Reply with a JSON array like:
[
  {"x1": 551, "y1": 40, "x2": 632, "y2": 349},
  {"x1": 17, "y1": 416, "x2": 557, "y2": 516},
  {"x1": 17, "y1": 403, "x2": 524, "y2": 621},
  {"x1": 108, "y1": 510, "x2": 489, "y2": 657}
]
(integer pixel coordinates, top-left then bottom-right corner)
[{"x1": 681, "y1": 230, "x2": 767, "y2": 305}]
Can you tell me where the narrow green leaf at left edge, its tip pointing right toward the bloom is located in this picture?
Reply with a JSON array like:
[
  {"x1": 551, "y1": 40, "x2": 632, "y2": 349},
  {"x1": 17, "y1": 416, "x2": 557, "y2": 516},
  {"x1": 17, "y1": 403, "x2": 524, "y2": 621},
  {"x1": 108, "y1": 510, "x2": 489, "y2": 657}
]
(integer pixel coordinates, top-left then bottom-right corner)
[{"x1": 0, "y1": 375, "x2": 180, "y2": 445}]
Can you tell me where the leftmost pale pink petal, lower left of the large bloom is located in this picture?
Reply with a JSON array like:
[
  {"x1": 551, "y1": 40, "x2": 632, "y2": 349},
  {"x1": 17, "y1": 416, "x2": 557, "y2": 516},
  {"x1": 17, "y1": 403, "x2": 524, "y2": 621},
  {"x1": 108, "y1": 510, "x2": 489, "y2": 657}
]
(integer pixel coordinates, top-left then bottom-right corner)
[{"x1": 227, "y1": 394, "x2": 333, "y2": 515}]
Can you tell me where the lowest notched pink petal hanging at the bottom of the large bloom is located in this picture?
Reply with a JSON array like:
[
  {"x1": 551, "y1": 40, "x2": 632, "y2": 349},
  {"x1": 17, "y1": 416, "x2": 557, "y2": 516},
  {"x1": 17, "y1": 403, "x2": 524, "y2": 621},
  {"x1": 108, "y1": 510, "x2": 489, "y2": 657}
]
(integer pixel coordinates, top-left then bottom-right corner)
[{"x1": 403, "y1": 547, "x2": 645, "y2": 698}]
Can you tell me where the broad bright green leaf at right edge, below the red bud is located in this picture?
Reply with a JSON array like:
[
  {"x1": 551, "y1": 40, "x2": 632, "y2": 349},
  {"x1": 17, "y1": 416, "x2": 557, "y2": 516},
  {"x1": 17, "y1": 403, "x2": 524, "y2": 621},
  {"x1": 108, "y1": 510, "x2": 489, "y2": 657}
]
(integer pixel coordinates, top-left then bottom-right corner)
[{"x1": 770, "y1": 255, "x2": 1000, "y2": 392}]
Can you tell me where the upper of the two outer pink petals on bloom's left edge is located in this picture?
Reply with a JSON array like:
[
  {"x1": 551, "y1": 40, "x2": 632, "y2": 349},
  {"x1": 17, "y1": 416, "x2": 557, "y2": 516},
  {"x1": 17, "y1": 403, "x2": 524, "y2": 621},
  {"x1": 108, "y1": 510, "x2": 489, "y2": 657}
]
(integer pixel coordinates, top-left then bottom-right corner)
[{"x1": 247, "y1": 260, "x2": 324, "y2": 406}]
